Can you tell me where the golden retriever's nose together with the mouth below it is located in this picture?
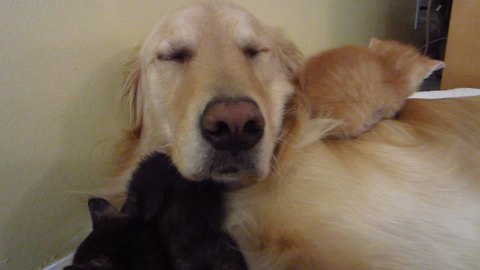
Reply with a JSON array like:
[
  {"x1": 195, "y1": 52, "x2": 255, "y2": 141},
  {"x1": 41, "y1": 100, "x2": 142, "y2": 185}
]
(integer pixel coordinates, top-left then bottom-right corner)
[{"x1": 200, "y1": 98, "x2": 265, "y2": 179}]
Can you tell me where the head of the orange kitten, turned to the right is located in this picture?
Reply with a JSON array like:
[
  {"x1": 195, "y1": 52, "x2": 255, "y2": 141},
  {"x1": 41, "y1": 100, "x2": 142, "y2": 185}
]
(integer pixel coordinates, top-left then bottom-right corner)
[{"x1": 369, "y1": 38, "x2": 445, "y2": 90}]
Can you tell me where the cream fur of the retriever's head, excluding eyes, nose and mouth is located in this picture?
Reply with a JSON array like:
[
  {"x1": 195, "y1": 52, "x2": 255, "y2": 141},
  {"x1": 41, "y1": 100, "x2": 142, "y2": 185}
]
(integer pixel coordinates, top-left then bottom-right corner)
[{"x1": 117, "y1": 1, "x2": 301, "y2": 186}]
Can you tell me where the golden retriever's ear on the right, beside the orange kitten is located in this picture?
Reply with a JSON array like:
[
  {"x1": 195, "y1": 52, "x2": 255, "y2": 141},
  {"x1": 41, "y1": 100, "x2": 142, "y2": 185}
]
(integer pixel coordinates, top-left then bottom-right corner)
[{"x1": 270, "y1": 28, "x2": 303, "y2": 81}]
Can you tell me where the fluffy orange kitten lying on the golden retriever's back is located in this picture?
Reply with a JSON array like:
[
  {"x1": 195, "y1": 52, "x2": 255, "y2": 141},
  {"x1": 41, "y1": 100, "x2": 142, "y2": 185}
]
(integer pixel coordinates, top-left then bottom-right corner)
[{"x1": 301, "y1": 38, "x2": 444, "y2": 138}]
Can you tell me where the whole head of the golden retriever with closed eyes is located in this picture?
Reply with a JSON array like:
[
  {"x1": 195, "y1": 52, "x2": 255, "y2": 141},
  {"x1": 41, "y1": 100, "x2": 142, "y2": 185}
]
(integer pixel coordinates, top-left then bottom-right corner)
[{"x1": 126, "y1": 1, "x2": 301, "y2": 181}]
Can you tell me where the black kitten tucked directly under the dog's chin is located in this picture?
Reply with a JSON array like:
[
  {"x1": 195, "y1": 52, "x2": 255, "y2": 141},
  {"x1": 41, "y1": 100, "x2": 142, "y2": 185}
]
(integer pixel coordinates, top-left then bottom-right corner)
[{"x1": 122, "y1": 153, "x2": 247, "y2": 270}]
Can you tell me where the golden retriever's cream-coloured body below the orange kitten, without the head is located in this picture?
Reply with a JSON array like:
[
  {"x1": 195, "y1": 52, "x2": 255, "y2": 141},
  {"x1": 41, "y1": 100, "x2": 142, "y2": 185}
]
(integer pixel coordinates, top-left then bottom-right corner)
[{"x1": 228, "y1": 97, "x2": 480, "y2": 269}]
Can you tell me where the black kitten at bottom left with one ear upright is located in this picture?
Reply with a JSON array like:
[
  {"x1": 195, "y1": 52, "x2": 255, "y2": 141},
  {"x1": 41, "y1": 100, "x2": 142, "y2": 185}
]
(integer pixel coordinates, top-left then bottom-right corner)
[{"x1": 64, "y1": 198, "x2": 174, "y2": 270}]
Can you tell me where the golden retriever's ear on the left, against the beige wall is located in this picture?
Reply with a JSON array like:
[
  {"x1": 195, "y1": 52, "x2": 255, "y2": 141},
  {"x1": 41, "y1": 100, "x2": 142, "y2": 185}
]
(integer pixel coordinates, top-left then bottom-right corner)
[{"x1": 123, "y1": 51, "x2": 143, "y2": 136}]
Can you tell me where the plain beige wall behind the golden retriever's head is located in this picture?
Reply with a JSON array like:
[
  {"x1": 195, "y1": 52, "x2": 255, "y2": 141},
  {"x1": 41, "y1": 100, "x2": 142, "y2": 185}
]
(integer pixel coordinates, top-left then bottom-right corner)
[{"x1": 0, "y1": 0, "x2": 415, "y2": 269}]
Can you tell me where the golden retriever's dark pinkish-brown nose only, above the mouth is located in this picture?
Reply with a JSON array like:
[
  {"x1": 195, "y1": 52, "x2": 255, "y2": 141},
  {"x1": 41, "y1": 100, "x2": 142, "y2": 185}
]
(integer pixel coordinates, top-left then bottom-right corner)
[{"x1": 200, "y1": 99, "x2": 265, "y2": 154}]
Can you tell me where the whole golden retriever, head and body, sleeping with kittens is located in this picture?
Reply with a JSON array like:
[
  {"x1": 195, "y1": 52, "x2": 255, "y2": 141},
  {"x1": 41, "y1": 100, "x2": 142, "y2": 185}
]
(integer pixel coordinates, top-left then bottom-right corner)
[{"x1": 116, "y1": 1, "x2": 480, "y2": 270}]
